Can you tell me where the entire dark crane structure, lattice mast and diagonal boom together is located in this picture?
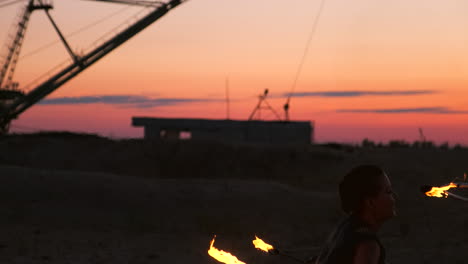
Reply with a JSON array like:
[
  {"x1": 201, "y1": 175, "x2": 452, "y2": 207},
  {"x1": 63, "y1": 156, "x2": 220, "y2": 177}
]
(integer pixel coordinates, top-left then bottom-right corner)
[{"x1": 0, "y1": 0, "x2": 187, "y2": 134}]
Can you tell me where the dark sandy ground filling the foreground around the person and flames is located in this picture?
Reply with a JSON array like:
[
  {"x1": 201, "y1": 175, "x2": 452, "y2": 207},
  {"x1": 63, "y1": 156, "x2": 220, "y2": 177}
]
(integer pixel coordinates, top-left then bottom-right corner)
[{"x1": 0, "y1": 135, "x2": 468, "y2": 264}]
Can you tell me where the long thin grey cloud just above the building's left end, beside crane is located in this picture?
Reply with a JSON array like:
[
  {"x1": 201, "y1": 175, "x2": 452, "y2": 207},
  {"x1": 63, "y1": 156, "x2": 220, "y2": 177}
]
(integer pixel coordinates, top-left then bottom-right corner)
[{"x1": 40, "y1": 95, "x2": 219, "y2": 108}]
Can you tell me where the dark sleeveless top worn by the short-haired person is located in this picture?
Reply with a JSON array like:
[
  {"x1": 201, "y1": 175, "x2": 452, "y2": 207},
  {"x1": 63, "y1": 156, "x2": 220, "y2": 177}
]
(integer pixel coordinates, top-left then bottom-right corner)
[{"x1": 315, "y1": 216, "x2": 385, "y2": 264}]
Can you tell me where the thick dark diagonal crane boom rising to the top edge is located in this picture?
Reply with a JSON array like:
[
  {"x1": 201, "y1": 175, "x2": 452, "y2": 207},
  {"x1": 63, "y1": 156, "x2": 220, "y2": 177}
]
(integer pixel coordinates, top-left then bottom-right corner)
[{"x1": 0, "y1": 0, "x2": 186, "y2": 131}]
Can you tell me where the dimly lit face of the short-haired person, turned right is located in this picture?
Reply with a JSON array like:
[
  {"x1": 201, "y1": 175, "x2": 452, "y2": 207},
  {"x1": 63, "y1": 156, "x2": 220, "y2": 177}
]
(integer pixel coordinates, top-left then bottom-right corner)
[{"x1": 372, "y1": 174, "x2": 396, "y2": 221}]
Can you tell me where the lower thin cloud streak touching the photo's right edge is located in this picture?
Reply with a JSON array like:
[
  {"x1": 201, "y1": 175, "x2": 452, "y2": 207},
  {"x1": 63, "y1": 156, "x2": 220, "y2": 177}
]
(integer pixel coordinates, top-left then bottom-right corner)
[{"x1": 336, "y1": 107, "x2": 468, "y2": 114}]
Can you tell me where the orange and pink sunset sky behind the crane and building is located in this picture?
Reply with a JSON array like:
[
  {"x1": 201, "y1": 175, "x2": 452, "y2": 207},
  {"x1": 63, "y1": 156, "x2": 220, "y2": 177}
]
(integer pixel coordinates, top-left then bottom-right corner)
[{"x1": 0, "y1": 0, "x2": 468, "y2": 145}]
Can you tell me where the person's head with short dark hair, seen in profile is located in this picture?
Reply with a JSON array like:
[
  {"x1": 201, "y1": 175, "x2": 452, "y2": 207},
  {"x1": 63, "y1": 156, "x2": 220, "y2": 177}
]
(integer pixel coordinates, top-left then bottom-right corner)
[{"x1": 339, "y1": 165, "x2": 395, "y2": 221}]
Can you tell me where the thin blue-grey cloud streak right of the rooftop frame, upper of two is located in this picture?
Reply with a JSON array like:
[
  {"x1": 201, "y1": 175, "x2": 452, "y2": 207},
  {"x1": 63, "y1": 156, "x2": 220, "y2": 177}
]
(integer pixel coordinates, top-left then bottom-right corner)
[{"x1": 284, "y1": 90, "x2": 438, "y2": 97}]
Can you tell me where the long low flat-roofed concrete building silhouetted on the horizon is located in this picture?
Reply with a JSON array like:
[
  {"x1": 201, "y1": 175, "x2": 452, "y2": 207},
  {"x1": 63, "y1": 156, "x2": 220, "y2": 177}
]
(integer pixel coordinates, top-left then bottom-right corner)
[{"x1": 132, "y1": 117, "x2": 314, "y2": 144}]
